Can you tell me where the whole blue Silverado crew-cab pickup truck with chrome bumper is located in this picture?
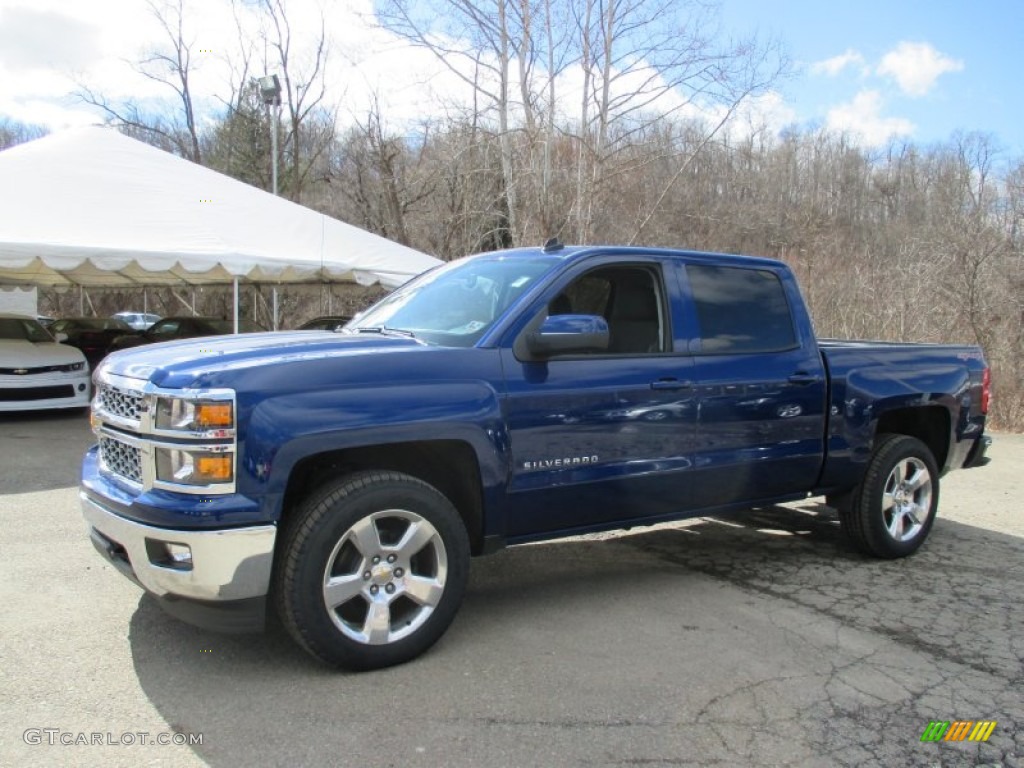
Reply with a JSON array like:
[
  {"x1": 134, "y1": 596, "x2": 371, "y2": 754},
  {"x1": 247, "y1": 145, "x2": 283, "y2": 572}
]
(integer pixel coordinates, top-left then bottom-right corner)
[{"x1": 81, "y1": 243, "x2": 990, "y2": 669}]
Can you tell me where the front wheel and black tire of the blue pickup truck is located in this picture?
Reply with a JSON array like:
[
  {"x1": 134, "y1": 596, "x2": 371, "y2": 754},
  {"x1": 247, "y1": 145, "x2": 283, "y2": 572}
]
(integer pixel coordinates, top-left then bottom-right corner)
[{"x1": 274, "y1": 472, "x2": 469, "y2": 670}]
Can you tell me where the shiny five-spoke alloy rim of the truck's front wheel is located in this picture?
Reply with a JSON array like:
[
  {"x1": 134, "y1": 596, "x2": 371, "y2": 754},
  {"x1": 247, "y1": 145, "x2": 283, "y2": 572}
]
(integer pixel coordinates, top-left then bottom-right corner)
[{"x1": 324, "y1": 509, "x2": 447, "y2": 645}]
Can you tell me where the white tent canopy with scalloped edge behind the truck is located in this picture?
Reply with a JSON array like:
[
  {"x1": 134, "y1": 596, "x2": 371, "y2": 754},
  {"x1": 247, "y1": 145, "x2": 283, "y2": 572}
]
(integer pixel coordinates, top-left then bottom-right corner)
[{"x1": 0, "y1": 127, "x2": 440, "y2": 288}]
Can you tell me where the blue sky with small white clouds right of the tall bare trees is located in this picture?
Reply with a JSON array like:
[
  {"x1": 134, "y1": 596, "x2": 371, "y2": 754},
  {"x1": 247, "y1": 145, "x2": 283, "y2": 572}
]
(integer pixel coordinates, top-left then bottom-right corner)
[{"x1": 721, "y1": 0, "x2": 1024, "y2": 158}]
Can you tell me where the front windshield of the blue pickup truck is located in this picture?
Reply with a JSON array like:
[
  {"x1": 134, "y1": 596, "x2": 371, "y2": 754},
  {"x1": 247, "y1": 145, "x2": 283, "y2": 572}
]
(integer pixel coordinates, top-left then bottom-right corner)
[{"x1": 345, "y1": 256, "x2": 558, "y2": 347}]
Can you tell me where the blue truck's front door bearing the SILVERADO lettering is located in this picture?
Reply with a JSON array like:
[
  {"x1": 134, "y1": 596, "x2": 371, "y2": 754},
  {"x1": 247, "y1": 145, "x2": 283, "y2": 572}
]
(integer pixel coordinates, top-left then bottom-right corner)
[{"x1": 503, "y1": 264, "x2": 696, "y2": 540}]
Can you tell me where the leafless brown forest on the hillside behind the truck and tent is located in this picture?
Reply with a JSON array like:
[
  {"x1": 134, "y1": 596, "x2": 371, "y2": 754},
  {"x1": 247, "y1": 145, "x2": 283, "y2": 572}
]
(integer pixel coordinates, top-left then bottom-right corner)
[{"x1": 0, "y1": 0, "x2": 1024, "y2": 430}]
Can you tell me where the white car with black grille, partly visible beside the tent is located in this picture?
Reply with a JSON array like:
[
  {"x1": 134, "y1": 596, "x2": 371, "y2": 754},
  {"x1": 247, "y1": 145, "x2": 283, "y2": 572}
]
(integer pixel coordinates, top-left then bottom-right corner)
[{"x1": 0, "y1": 313, "x2": 89, "y2": 411}]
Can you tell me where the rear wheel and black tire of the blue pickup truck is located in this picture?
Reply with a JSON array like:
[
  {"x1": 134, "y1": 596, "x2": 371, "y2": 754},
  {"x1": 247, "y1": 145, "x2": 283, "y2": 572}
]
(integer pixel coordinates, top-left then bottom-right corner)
[{"x1": 838, "y1": 434, "x2": 939, "y2": 558}]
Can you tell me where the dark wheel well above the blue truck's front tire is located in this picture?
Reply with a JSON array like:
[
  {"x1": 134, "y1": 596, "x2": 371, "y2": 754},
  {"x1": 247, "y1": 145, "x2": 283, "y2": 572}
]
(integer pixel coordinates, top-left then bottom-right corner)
[{"x1": 282, "y1": 440, "x2": 483, "y2": 555}]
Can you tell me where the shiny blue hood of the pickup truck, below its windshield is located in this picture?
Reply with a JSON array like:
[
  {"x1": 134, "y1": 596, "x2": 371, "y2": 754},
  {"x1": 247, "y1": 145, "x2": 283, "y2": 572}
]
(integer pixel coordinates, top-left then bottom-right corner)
[{"x1": 98, "y1": 331, "x2": 426, "y2": 388}]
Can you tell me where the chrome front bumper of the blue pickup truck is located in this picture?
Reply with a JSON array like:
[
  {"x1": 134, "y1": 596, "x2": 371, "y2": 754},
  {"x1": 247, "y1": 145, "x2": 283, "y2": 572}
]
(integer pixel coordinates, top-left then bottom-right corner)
[{"x1": 81, "y1": 494, "x2": 278, "y2": 601}]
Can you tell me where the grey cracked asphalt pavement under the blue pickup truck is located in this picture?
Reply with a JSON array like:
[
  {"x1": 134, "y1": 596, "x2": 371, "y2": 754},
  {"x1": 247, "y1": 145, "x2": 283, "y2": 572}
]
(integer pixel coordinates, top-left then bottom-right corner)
[{"x1": 0, "y1": 415, "x2": 1024, "y2": 767}]
